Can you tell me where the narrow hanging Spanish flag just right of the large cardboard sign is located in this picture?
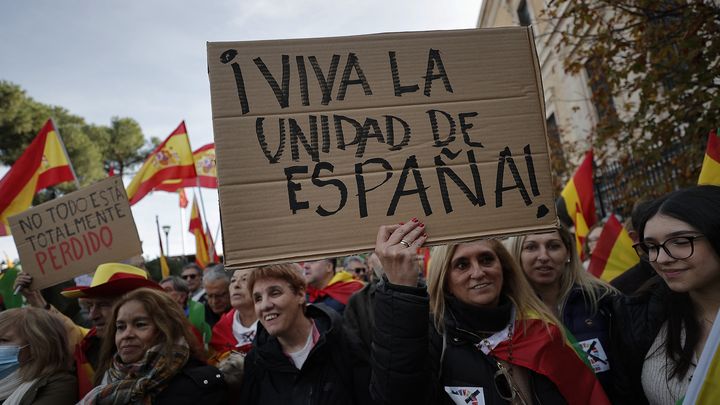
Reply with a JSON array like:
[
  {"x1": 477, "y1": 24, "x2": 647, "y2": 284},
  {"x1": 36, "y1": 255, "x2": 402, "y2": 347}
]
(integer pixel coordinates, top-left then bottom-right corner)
[{"x1": 558, "y1": 150, "x2": 597, "y2": 258}]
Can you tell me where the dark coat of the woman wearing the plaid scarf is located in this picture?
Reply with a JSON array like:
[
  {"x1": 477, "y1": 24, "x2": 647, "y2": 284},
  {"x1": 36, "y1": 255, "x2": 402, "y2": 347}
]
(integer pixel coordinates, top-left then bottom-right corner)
[{"x1": 153, "y1": 357, "x2": 228, "y2": 405}]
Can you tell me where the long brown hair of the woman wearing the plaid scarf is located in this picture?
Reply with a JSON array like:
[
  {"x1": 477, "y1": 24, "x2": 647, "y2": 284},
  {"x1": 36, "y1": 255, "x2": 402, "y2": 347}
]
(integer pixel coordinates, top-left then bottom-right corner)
[{"x1": 95, "y1": 288, "x2": 206, "y2": 385}]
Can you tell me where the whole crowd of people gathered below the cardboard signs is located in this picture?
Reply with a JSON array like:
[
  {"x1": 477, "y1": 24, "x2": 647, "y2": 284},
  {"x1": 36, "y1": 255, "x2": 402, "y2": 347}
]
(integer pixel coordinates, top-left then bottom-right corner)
[{"x1": 0, "y1": 186, "x2": 720, "y2": 405}]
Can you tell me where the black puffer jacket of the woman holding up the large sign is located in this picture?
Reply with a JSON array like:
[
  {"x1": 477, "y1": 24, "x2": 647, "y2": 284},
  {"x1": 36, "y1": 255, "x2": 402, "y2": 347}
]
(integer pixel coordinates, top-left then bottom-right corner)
[{"x1": 370, "y1": 281, "x2": 566, "y2": 405}]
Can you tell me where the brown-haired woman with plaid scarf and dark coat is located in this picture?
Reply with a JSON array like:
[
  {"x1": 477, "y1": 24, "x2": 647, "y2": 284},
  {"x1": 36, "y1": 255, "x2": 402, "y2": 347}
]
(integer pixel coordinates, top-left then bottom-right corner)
[{"x1": 80, "y1": 288, "x2": 227, "y2": 405}]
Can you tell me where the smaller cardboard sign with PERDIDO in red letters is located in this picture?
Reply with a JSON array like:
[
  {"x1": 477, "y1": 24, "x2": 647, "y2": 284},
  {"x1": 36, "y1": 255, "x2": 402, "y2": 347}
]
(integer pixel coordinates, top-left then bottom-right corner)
[{"x1": 9, "y1": 177, "x2": 142, "y2": 289}]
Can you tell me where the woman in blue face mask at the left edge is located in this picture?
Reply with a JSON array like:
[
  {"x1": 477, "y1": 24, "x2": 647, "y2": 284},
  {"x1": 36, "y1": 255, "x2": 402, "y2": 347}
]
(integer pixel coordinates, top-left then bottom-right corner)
[{"x1": 0, "y1": 307, "x2": 78, "y2": 405}]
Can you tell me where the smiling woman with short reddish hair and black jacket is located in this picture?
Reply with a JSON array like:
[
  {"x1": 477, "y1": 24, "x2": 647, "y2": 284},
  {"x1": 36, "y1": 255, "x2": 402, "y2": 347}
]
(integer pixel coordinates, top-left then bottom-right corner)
[{"x1": 238, "y1": 264, "x2": 370, "y2": 405}]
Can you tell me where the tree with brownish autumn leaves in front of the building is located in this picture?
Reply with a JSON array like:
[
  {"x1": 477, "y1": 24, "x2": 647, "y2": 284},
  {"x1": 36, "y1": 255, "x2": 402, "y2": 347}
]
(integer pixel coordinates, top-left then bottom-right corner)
[{"x1": 545, "y1": 0, "x2": 720, "y2": 211}]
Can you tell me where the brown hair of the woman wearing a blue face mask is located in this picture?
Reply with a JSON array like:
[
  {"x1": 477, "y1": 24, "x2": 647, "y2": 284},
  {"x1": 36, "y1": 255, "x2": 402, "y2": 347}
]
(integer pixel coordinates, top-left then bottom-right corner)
[{"x1": 0, "y1": 307, "x2": 72, "y2": 381}]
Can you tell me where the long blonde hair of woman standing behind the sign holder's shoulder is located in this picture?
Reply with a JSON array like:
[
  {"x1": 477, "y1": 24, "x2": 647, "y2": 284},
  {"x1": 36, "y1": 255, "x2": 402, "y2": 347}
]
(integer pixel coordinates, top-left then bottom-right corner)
[{"x1": 508, "y1": 228, "x2": 617, "y2": 314}]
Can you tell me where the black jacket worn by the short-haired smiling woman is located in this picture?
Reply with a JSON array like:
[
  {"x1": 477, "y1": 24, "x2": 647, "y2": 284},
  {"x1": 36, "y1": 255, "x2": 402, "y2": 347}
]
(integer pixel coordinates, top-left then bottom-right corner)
[{"x1": 237, "y1": 304, "x2": 370, "y2": 405}]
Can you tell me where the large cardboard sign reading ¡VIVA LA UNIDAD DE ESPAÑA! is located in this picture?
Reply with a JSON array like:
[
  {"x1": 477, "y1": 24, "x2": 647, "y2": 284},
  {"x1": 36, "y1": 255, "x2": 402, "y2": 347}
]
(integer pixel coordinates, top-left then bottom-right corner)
[{"x1": 208, "y1": 27, "x2": 557, "y2": 267}]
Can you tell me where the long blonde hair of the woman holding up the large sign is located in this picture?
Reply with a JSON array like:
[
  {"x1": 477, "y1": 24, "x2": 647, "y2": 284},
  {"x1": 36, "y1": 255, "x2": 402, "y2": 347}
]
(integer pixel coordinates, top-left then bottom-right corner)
[{"x1": 427, "y1": 239, "x2": 560, "y2": 333}]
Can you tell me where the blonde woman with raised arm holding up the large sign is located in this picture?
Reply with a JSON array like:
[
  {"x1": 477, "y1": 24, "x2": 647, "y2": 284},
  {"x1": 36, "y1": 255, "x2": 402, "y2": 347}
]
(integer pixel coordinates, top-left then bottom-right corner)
[{"x1": 370, "y1": 218, "x2": 608, "y2": 404}]
